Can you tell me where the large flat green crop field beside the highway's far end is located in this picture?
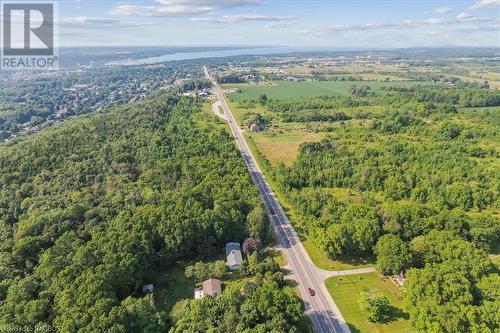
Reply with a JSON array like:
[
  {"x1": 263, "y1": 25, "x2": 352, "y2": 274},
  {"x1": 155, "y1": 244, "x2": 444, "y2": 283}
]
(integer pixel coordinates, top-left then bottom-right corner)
[{"x1": 224, "y1": 80, "x2": 429, "y2": 102}]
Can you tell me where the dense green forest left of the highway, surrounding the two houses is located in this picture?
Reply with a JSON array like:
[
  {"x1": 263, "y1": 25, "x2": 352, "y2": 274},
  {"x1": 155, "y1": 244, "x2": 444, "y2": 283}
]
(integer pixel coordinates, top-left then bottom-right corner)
[{"x1": 0, "y1": 93, "x2": 302, "y2": 332}]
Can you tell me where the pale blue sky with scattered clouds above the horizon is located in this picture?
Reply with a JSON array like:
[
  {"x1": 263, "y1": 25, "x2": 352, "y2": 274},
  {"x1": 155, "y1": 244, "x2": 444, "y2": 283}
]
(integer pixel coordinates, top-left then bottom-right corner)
[{"x1": 55, "y1": 0, "x2": 500, "y2": 48}]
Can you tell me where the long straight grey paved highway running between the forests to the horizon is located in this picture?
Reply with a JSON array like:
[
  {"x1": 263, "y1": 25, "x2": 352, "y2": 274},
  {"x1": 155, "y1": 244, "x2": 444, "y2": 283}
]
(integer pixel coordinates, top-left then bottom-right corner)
[{"x1": 204, "y1": 67, "x2": 350, "y2": 333}]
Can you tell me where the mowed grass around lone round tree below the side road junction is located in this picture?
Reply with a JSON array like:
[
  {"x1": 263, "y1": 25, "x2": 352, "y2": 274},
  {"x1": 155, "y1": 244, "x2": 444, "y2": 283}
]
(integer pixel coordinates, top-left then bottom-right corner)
[{"x1": 325, "y1": 273, "x2": 413, "y2": 333}]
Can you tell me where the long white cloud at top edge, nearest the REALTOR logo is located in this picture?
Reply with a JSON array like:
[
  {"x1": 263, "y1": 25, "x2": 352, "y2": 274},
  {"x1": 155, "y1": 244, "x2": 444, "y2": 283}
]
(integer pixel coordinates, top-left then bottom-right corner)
[{"x1": 108, "y1": 0, "x2": 261, "y2": 16}]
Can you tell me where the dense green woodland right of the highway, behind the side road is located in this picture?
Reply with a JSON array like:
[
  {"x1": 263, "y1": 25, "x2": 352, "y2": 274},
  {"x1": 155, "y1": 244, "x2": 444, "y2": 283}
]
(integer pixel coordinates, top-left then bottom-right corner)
[{"x1": 255, "y1": 85, "x2": 500, "y2": 333}]
